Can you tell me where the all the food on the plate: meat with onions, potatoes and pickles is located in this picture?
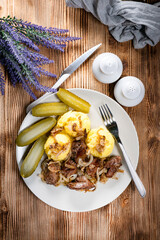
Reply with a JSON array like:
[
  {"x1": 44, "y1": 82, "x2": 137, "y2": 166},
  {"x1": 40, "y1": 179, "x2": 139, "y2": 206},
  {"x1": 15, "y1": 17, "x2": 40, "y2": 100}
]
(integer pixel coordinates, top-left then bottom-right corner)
[{"x1": 16, "y1": 89, "x2": 122, "y2": 191}]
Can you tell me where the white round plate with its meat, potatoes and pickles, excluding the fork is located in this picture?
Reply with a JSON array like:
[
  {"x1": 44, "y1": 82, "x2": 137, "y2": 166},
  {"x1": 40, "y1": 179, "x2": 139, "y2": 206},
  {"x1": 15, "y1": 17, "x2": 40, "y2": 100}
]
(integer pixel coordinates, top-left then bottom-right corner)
[{"x1": 16, "y1": 89, "x2": 138, "y2": 211}]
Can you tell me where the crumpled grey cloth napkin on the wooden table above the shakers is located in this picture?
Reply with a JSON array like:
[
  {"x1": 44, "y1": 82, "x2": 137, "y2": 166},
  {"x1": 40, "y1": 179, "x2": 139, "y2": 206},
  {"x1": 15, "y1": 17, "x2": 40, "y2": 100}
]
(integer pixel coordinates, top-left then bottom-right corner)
[{"x1": 66, "y1": 0, "x2": 160, "y2": 48}]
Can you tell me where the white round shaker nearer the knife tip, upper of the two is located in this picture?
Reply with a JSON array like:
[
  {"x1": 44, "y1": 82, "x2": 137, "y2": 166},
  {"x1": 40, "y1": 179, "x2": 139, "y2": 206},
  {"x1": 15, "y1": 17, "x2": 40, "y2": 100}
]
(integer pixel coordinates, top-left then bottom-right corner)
[{"x1": 92, "y1": 52, "x2": 123, "y2": 83}]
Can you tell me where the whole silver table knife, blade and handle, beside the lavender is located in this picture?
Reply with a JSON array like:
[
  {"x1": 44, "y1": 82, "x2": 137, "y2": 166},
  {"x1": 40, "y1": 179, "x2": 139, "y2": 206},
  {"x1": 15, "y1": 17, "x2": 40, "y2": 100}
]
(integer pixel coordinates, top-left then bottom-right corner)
[{"x1": 26, "y1": 43, "x2": 102, "y2": 113}]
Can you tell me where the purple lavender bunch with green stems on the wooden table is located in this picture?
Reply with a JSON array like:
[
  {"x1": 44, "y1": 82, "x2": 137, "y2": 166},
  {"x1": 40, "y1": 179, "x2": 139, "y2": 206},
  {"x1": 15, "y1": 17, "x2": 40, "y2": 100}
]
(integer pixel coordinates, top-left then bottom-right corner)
[{"x1": 0, "y1": 16, "x2": 79, "y2": 99}]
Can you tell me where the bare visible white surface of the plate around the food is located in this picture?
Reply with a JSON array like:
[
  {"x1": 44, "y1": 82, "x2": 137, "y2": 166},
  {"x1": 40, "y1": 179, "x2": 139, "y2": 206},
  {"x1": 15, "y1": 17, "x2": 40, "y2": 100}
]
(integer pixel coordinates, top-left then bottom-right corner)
[{"x1": 16, "y1": 89, "x2": 139, "y2": 212}]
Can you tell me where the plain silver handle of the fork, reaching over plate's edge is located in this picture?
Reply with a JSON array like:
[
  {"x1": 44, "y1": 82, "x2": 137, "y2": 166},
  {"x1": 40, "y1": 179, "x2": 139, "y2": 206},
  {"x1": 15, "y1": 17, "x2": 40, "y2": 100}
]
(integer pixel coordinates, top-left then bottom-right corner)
[{"x1": 118, "y1": 142, "x2": 146, "y2": 198}]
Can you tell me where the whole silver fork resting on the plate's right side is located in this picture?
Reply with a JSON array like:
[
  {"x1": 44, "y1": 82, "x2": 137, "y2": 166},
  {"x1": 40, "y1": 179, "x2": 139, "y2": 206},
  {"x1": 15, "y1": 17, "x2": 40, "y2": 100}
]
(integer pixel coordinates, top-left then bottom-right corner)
[{"x1": 99, "y1": 104, "x2": 146, "y2": 197}]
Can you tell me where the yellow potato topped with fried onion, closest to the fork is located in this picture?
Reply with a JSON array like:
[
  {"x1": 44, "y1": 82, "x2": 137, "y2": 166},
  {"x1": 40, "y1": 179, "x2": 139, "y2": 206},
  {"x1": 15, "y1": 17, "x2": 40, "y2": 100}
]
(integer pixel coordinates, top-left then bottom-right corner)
[{"x1": 86, "y1": 127, "x2": 114, "y2": 158}]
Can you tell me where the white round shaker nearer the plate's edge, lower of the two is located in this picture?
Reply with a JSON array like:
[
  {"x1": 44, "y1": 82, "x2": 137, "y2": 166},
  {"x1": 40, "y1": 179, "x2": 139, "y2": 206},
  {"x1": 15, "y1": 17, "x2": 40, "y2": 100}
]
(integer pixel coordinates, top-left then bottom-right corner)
[{"x1": 114, "y1": 76, "x2": 145, "y2": 107}]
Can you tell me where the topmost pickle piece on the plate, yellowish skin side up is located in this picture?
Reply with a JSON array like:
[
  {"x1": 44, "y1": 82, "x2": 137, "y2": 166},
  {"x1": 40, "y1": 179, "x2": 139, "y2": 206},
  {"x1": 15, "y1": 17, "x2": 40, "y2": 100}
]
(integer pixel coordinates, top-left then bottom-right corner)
[{"x1": 57, "y1": 88, "x2": 91, "y2": 113}]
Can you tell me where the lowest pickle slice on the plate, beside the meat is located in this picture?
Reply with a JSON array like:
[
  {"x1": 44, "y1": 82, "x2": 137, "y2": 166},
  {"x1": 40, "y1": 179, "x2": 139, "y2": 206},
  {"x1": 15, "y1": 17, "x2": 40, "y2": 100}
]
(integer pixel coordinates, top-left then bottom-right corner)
[{"x1": 20, "y1": 135, "x2": 47, "y2": 178}]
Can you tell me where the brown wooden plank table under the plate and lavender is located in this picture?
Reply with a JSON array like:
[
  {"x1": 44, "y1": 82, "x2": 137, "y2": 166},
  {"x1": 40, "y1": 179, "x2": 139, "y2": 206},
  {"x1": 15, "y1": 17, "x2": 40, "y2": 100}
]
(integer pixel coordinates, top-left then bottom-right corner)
[{"x1": 0, "y1": 0, "x2": 160, "y2": 240}]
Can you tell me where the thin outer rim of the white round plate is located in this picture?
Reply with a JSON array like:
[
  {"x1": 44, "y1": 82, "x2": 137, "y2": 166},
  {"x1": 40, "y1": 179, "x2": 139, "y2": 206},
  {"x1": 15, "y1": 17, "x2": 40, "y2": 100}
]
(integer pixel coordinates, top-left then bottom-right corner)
[{"x1": 16, "y1": 88, "x2": 139, "y2": 212}]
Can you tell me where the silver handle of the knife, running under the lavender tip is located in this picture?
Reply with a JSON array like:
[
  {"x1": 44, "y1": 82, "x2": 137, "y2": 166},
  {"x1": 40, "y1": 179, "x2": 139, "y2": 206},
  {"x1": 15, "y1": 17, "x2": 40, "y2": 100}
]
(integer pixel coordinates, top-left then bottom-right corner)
[{"x1": 26, "y1": 73, "x2": 70, "y2": 113}]
